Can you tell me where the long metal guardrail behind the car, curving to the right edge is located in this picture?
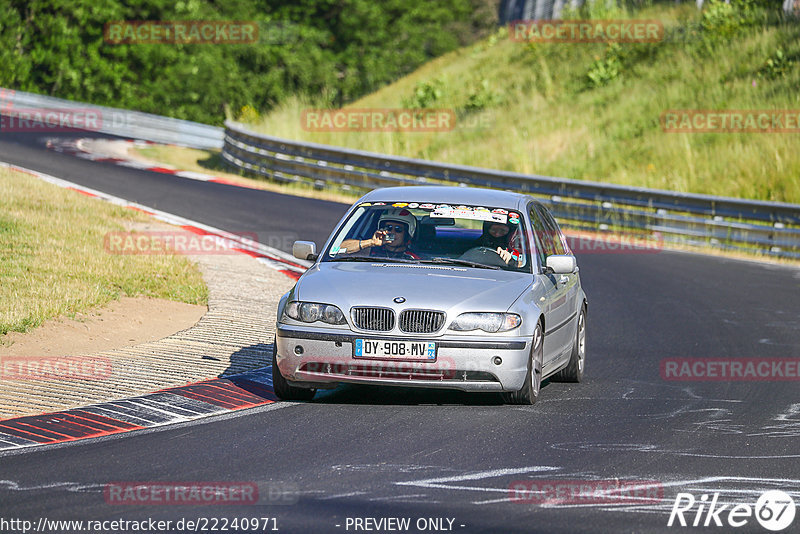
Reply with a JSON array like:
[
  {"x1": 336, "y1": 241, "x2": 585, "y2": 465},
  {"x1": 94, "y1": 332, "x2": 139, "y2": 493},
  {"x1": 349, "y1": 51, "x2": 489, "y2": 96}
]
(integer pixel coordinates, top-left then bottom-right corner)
[{"x1": 222, "y1": 121, "x2": 800, "y2": 258}]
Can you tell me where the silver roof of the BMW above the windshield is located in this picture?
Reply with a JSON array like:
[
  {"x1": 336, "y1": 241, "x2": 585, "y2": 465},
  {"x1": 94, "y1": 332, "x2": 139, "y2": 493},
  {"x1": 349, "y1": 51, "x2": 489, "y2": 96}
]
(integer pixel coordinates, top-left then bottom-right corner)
[{"x1": 361, "y1": 185, "x2": 532, "y2": 208}]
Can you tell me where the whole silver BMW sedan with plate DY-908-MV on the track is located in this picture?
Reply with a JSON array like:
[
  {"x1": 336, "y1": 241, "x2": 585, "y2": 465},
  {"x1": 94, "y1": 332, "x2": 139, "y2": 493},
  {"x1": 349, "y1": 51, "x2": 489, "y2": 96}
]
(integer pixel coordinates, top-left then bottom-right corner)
[{"x1": 272, "y1": 186, "x2": 587, "y2": 404}]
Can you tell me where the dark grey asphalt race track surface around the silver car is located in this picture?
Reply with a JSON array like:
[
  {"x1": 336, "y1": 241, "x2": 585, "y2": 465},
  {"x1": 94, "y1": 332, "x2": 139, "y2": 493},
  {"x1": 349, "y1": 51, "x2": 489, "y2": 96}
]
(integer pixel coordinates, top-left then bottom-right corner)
[{"x1": 0, "y1": 130, "x2": 800, "y2": 533}]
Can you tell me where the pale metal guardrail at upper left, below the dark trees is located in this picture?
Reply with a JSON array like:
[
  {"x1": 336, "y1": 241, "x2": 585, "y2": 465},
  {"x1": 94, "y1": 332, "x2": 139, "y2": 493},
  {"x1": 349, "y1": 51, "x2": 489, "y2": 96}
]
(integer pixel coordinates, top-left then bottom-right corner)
[{"x1": 0, "y1": 88, "x2": 224, "y2": 148}]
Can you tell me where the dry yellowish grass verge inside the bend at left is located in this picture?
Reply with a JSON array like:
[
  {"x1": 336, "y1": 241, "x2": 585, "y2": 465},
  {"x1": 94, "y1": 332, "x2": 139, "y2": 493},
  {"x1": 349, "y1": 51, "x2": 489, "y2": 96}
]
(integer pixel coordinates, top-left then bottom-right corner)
[{"x1": 0, "y1": 168, "x2": 208, "y2": 339}]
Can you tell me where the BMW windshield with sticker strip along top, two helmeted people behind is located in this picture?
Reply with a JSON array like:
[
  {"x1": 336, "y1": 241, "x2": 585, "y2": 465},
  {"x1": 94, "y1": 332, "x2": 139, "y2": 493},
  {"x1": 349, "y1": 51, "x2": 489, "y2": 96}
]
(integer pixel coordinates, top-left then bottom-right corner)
[{"x1": 321, "y1": 202, "x2": 531, "y2": 273}]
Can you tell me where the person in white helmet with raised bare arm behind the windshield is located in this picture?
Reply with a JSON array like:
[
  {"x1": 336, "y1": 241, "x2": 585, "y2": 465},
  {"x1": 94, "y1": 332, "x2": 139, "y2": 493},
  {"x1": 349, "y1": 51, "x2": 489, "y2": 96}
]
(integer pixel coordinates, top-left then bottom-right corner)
[{"x1": 341, "y1": 209, "x2": 420, "y2": 260}]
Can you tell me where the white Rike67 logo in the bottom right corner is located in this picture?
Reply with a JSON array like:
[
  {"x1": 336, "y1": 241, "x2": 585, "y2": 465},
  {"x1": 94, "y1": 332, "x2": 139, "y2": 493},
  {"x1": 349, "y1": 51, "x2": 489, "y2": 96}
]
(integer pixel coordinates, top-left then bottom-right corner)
[{"x1": 667, "y1": 490, "x2": 795, "y2": 532}]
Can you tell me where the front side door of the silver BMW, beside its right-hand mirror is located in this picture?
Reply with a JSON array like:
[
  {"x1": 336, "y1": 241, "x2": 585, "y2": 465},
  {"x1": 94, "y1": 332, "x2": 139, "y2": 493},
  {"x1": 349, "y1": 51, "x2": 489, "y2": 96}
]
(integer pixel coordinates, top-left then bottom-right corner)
[{"x1": 528, "y1": 203, "x2": 570, "y2": 373}]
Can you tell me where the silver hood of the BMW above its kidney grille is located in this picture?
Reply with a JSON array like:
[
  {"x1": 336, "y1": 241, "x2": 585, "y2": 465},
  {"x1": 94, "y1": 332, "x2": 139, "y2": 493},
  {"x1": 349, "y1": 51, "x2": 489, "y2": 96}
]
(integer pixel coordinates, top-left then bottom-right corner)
[{"x1": 294, "y1": 262, "x2": 533, "y2": 313}]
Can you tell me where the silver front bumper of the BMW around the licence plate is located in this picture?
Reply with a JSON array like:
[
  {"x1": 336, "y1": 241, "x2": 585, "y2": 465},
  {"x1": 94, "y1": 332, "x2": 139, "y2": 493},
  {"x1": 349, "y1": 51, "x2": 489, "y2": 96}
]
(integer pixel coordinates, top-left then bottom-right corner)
[{"x1": 276, "y1": 324, "x2": 531, "y2": 391}]
